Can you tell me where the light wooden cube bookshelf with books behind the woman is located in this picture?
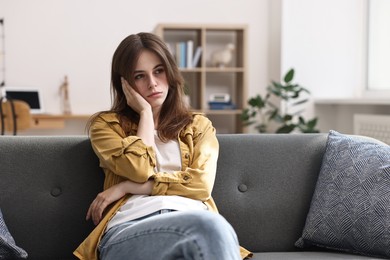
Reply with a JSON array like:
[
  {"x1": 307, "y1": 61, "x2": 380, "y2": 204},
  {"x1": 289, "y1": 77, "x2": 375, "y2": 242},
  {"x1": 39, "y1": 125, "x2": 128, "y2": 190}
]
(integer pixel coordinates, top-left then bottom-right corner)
[{"x1": 155, "y1": 24, "x2": 247, "y2": 133}]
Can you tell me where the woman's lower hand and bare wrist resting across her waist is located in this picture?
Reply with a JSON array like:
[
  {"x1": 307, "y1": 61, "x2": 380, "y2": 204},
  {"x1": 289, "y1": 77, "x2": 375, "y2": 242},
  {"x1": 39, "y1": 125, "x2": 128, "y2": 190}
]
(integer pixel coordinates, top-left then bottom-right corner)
[{"x1": 86, "y1": 180, "x2": 154, "y2": 225}]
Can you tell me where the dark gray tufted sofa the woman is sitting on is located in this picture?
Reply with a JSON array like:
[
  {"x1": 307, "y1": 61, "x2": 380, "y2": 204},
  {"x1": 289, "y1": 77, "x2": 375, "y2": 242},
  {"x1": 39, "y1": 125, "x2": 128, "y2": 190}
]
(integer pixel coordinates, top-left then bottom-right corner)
[{"x1": 0, "y1": 134, "x2": 384, "y2": 260}]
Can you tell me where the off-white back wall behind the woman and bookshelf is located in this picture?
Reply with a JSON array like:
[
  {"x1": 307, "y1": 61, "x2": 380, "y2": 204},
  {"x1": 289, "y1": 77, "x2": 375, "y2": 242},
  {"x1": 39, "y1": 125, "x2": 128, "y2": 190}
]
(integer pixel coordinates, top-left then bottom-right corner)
[{"x1": 0, "y1": 0, "x2": 274, "y2": 114}]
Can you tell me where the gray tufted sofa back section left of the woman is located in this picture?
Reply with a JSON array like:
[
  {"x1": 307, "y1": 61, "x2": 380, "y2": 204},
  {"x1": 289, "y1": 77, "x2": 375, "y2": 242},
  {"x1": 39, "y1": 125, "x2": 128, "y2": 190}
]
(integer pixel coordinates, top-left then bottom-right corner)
[{"x1": 0, "y1": 136, "x2": 104, "y2": 259}]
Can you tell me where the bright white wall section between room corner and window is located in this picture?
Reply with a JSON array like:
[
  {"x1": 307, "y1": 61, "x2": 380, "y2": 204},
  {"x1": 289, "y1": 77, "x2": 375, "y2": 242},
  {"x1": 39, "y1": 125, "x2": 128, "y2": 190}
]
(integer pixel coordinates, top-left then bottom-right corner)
[{"x1": 281, "y1": 0, "x2": 366, "y2": 98}]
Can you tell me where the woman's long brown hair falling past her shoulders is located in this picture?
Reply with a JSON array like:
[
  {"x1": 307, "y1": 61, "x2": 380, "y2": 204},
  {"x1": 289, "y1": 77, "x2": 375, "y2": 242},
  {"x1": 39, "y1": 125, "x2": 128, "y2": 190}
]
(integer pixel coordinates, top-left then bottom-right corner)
[{"x1": 92, "y1": 32, "x2": 192, "y2": 141}]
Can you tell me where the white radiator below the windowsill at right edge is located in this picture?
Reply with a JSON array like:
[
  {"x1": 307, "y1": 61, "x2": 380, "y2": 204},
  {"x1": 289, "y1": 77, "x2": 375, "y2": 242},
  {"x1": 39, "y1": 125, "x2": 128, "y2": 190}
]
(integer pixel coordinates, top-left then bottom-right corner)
[{"x1": 353, "y1": 114, "x2": 390, "y2": 145}]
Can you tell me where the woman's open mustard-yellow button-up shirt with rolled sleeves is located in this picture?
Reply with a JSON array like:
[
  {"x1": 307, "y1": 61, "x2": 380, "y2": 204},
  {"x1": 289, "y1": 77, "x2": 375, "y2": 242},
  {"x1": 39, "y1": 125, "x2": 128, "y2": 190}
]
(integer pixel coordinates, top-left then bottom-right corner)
[{"x1": 73, "y1": 113, "x2": 250, "y2": 260}]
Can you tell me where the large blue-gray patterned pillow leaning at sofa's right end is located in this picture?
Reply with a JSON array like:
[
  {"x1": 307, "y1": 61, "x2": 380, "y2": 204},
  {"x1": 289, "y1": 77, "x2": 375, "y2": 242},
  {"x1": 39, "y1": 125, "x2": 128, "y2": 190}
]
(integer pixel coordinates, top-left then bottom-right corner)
[{"x1": 295, "y1": 131, "x2": 390, "y2": 257}]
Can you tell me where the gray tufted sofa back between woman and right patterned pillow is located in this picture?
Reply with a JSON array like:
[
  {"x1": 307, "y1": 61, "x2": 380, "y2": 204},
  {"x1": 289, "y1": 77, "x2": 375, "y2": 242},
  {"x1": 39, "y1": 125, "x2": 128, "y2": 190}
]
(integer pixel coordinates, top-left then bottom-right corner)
[{"x1": 213, "y1": 134, "x2": 327, "y2": 252}]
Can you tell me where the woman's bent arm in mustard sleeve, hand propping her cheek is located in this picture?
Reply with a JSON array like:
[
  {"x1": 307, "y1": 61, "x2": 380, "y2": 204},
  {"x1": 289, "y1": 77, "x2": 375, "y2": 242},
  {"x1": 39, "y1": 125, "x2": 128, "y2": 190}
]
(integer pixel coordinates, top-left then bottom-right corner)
[{"x1": 90, "y1": 78, "x2": 156, "y2": 183}]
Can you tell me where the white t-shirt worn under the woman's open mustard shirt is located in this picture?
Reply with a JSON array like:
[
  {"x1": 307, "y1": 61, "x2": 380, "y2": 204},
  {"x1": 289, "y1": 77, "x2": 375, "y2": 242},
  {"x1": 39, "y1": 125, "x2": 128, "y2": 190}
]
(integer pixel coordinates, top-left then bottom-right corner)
[{"x1": 106, "y1": 132, "x2": 207, "y2": 230}]
